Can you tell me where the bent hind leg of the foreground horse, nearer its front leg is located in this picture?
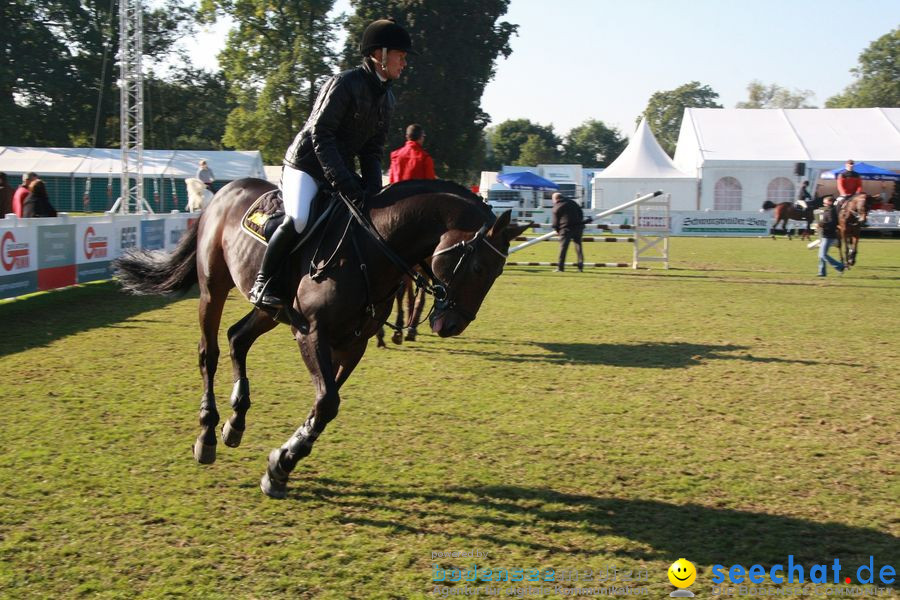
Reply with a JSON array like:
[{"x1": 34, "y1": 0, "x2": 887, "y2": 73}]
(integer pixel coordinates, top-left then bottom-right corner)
[{"x1": 222, "y1": 309, "x2": 278, "y2": 448}]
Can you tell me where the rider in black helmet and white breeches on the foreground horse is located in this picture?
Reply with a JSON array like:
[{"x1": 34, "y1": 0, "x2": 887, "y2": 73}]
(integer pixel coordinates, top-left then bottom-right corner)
[{"x1": 249, "y1": 19, "x2": 415, "y2": 310}]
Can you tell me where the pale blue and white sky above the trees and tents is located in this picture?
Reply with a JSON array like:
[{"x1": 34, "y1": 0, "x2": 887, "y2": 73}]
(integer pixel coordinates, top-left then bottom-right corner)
[{"x1": 179, "y1": 0, "x2": 900, "y2": 136}]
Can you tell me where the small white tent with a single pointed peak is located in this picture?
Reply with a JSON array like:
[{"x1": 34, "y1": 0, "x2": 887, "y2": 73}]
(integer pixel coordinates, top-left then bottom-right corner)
[{"x1": 592, "y1": 119, "x2": 697, "y2": 210}]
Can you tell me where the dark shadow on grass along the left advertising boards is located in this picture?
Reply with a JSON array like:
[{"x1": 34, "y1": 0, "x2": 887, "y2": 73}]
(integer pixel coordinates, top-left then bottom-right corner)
[{"x1": 0, "y1": 281, "x2": 197, "y2": 356}]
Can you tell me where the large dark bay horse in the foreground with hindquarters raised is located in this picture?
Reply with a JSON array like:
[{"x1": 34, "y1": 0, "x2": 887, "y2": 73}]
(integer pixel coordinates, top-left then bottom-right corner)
[{"x1": 115, "y1": 179, "x2": 529, "y2": 498}]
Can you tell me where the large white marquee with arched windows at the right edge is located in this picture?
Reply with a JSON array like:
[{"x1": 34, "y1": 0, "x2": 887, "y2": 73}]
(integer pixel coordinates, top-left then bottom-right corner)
[{"x1": 674, "y1": 108, "x2": 900, "y2": 210}]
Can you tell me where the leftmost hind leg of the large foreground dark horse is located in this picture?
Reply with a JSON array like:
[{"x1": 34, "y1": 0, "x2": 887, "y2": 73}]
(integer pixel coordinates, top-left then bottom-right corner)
[{"x1": 192, "y1": 285, "x2": 228, "y2": 465}]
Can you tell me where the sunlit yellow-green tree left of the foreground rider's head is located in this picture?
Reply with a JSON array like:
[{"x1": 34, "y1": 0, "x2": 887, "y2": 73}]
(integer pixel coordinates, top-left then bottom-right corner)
[{"x1": 200, "y1": 0, "x2": 339, "y2": 163}]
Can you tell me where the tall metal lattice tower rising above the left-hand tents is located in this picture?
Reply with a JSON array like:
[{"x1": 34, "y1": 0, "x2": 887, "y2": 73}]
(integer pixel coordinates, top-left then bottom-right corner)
[{"x1": 112, "y1": 0, "x2": 153, "y2": 213}]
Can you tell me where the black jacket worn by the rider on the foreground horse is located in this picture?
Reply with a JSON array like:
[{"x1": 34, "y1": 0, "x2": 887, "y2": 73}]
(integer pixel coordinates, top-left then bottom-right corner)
[{"x1": 284, "y1": 58, "x2": 395, "y2": 197}]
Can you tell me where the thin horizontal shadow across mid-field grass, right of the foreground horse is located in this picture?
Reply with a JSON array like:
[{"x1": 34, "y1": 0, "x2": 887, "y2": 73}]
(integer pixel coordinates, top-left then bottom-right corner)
[{"x1": 419, "y1": 342, "x2": 836, "y2": 369}]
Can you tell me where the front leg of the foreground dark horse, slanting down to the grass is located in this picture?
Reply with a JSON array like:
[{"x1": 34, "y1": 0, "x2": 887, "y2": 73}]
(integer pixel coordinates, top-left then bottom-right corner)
[{"x1": 259, "y1": 331, "x2": 366, "y2": 499}]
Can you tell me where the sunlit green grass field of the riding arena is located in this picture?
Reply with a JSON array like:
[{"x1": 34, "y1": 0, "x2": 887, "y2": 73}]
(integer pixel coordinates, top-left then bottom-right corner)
[{"x1": 0, "y1": 238, "x2": 900, "y2": 599}]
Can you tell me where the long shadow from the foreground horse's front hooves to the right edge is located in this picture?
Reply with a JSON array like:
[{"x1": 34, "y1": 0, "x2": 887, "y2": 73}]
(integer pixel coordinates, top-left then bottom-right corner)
[{"x1": 289, "y1": 477, "x2": 900, "y2": 576}]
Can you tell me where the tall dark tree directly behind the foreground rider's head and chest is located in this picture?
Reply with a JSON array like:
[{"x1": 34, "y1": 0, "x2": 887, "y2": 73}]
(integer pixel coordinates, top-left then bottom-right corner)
[{"x1": 343, "y1": 0, "x2": 516, "y2": 179}]
